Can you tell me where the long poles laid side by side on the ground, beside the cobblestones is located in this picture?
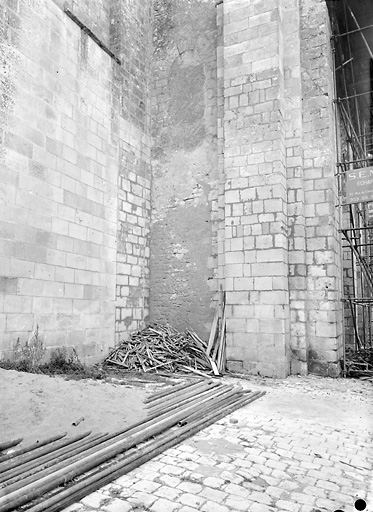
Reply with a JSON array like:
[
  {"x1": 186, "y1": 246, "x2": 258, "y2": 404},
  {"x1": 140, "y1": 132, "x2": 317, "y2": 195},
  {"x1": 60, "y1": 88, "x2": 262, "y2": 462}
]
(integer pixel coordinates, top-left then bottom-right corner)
[{"x1": 0, "y1": 379, "x2": 264, "y2": 512}]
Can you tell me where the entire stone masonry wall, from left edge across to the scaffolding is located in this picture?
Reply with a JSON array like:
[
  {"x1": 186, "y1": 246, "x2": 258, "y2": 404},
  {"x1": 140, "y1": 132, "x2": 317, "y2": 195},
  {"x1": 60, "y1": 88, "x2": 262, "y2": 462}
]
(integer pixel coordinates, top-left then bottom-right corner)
[{"x1": 0, "y1": 0, "x2": 343, "y2": 377}]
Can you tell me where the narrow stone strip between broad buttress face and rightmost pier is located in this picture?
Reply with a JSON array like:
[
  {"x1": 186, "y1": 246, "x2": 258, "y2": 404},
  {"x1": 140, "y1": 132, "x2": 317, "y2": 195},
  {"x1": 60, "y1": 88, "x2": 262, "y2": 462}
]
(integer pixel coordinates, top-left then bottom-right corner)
[{"x1": 283, "y1": 0, "x2": 308, "y2": 374}]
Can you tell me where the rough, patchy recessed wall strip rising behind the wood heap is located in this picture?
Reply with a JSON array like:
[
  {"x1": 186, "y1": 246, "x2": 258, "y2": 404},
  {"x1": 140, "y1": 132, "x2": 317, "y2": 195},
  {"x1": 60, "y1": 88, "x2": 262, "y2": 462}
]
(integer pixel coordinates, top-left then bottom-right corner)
[{"x1": 150, "y1": 0, "x2": 218, "y2": 339}]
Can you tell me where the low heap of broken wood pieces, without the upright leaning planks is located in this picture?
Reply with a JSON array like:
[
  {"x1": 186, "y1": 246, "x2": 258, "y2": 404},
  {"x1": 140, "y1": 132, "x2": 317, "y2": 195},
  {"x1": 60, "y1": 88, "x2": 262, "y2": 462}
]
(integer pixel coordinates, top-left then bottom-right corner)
[{"x1": 104, "y1": 324, "x2": 212, "y2": 373}]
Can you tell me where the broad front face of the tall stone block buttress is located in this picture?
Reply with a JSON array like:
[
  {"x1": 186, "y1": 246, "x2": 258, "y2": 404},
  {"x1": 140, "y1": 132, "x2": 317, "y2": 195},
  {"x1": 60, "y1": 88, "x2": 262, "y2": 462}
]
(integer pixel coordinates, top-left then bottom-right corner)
[{"x1": 224, "y1": 1, "x2": 289, "y2": 375}]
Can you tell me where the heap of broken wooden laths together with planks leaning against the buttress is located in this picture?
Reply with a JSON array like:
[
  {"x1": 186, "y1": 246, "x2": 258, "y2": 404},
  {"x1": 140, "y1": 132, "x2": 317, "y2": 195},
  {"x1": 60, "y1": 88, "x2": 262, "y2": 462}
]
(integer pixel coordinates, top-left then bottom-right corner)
[{"x1": 104, "y1": 292, "x2": 226, "y2": 375}]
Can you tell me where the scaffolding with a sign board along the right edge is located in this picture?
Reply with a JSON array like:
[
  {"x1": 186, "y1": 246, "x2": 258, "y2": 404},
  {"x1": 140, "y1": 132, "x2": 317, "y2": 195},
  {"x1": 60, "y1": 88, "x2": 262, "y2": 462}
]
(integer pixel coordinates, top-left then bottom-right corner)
[{"x1": 328, "y1": 0, "x2": 373, "y2": 352}]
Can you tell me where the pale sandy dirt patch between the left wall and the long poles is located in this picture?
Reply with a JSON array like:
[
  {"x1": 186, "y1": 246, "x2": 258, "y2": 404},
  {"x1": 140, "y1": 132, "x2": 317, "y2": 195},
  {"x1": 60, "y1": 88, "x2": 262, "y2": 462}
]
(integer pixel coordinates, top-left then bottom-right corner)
[{"x1": 0, "y1": 369, "x2": 171, "y2": 446}]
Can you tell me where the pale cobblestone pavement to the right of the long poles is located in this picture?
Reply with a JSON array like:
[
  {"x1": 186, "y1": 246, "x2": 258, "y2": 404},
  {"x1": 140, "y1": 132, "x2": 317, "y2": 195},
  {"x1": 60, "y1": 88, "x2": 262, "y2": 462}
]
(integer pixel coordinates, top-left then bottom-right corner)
[{"x1": 65, "y1": 376, "x2": 373, "y2": 512}]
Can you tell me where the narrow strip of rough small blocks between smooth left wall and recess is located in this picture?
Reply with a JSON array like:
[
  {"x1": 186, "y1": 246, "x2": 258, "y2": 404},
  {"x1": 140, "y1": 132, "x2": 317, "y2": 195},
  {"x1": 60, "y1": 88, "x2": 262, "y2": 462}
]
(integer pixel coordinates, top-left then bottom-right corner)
[{"x1": 110, "y1": 0, "x2": 152, "y2": 342}]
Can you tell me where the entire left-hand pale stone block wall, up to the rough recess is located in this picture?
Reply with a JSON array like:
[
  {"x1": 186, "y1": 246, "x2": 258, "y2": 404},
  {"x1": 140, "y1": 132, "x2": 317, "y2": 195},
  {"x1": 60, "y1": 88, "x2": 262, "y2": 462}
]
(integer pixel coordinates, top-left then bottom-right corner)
[{"x1": 0, "y1": 0, "x2": 150, "y2": 361}]
